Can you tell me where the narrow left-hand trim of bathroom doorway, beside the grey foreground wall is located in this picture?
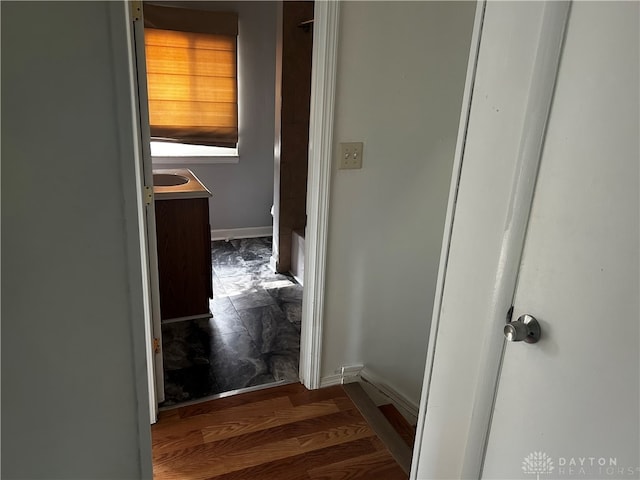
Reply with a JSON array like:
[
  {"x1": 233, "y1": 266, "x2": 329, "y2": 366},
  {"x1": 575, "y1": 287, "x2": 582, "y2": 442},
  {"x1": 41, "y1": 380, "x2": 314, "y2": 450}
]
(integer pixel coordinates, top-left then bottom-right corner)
[{"x1": 106, "y1": 1, "x2": 157, "y2": 472}]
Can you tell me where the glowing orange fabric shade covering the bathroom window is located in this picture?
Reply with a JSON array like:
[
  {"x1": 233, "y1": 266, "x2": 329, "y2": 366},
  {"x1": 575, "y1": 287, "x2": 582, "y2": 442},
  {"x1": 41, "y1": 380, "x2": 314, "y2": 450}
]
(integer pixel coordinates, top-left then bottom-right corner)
[{"x1": 145, "y1": 6, "x2": 238, "y2": 147}]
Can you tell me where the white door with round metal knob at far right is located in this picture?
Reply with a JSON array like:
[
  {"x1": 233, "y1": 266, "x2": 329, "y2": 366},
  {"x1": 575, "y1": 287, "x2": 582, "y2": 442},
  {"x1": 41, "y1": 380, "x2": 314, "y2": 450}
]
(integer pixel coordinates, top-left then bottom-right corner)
[{"x1": 483, "y1": 2, "x2": 640, "y2": 479}]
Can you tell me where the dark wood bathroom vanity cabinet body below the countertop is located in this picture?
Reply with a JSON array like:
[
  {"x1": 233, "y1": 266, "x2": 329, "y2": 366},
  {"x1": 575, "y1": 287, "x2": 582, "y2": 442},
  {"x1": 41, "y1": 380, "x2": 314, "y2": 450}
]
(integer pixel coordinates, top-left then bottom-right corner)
[{"x1": 155, "y1": 198, "x2": 213, "y2": 320}]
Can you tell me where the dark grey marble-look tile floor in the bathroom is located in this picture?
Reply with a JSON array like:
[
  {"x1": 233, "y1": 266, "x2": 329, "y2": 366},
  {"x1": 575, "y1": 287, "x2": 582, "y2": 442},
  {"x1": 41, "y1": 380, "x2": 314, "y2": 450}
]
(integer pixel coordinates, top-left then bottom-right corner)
[{"x1": 160, "y1": 237, "x2": 302, "y2": 407}]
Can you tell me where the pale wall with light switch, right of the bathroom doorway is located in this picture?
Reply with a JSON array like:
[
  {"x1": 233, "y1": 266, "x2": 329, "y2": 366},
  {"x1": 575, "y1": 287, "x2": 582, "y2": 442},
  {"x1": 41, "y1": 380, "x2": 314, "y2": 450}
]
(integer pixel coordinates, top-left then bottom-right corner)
[{"x1": 322, "y1": 2, "x2": 475, "y2": 405}]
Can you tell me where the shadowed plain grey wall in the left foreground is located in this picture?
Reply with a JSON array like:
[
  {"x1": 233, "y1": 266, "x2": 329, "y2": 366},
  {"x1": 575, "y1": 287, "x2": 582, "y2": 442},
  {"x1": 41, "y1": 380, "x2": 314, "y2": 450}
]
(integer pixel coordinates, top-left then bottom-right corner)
[{"x1": 2, "y1": 2, "x2": 151, "y2": 479}]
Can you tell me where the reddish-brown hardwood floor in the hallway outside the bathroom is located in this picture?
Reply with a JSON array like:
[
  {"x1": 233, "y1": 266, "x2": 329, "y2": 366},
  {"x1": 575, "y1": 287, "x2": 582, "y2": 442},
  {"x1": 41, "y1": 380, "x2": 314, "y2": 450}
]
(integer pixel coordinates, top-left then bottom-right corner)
[{"x1": 152, "y1": 384, "x2": 407, "y2": 480}]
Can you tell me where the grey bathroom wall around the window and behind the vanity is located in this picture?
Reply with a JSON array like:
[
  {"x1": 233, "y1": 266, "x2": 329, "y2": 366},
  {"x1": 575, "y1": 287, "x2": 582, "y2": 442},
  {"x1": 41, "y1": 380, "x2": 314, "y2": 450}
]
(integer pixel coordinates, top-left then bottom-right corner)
[{"x1": 154, "y1": 1, "x2": 277, "y2": 230}]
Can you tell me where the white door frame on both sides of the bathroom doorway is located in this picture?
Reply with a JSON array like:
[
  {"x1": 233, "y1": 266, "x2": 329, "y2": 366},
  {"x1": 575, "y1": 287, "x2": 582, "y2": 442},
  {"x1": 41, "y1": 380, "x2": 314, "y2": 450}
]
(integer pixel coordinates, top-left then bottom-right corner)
[{"x1": 124, "y1": 1, "x2": 340, "y2": 408}]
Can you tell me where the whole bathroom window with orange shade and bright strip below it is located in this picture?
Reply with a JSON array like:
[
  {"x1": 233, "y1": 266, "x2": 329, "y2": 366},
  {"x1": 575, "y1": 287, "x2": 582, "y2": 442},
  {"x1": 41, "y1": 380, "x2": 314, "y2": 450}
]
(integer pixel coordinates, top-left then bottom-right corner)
[{"x1": 144, "y1": 3, "x2": 238, "y2": 157}]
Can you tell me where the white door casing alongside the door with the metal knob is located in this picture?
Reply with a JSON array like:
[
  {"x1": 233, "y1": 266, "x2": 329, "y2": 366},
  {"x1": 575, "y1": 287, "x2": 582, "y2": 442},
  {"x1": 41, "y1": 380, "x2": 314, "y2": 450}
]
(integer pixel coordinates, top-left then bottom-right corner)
[{"x1": 410, "y1": 1, "x2": 570, "y2": 479}]
